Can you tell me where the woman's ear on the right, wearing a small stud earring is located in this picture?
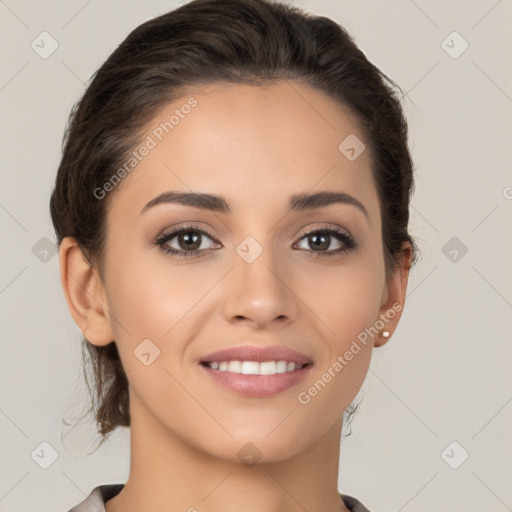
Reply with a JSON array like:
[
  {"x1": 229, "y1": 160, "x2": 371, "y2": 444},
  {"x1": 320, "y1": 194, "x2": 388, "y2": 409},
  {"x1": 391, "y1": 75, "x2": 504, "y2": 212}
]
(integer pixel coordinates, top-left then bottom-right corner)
[{"x1": 374, "y1": 242, "x2": 412, "y2": 347}]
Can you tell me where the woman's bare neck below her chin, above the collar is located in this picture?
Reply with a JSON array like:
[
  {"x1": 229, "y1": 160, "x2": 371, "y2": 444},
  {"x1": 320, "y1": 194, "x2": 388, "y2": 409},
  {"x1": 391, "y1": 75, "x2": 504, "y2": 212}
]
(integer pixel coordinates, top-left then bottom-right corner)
[{"x1": 106, "y1": 396, "x2": 347, "y2": 512}]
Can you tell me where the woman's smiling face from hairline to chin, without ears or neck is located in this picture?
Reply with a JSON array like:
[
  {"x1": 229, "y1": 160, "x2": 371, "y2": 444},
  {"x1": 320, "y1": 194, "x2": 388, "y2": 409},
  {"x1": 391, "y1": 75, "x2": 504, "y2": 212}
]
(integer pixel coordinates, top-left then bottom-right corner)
[{"x1": 77, "y1": 81, "x2": 399, "y2": 462}]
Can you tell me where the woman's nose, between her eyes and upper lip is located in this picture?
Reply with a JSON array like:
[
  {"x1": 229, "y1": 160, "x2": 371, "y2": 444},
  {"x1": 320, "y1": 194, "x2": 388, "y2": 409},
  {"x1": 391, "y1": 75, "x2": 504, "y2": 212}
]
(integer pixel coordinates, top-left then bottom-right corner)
[{"x1": 224, "y1": 243, "x2": 298, "y2": 329}]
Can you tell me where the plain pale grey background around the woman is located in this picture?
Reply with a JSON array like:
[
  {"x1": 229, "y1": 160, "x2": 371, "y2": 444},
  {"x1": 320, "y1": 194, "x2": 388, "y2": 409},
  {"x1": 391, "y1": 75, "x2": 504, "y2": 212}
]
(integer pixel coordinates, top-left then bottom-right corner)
[{"x1": 0, "y1": 0, "x2": 512, "y2": 512}]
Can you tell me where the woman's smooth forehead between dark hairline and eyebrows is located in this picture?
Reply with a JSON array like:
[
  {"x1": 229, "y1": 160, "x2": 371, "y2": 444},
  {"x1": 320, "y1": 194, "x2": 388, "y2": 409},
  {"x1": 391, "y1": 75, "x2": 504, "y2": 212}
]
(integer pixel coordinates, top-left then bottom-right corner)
[{"x1": 112, "y1": 80, "x2": 378, "y2": 222}]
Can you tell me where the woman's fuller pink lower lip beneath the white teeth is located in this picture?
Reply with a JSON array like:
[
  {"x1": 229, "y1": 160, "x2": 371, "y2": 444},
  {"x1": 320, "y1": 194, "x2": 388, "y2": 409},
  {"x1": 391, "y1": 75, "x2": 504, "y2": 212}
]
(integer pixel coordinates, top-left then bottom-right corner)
[{"x1": 199, "y1": 364, "x2": 313, "y2": 398}]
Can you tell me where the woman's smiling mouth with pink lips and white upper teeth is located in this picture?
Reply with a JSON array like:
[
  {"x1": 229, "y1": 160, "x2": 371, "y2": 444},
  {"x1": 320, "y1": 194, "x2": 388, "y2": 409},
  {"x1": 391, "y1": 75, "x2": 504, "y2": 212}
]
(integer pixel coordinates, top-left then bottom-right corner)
[{"x1": 200, "y1": 345, "x2": 314, "y2": 398}]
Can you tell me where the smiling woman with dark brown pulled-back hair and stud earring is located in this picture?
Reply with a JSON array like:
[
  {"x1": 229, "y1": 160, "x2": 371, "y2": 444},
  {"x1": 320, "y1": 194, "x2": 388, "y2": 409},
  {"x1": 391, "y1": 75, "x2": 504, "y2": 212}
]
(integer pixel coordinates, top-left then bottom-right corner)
[{"x1": 51, "y1": 0, "x2": 416, "y2": 512}]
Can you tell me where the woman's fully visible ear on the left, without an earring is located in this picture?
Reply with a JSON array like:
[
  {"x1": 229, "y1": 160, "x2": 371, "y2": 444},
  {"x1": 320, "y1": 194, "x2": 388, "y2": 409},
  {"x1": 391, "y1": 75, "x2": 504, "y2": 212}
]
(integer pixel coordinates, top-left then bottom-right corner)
[{"x1": 59, "y1": 237, "x2": 114, "y2": 346}]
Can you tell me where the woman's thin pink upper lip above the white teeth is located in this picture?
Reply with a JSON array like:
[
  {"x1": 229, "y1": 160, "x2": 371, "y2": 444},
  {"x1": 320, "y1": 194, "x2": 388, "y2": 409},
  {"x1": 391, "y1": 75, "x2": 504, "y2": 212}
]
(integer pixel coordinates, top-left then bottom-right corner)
[{"x1": 200, "y1": 345, "x2": 313, "y2": 365}]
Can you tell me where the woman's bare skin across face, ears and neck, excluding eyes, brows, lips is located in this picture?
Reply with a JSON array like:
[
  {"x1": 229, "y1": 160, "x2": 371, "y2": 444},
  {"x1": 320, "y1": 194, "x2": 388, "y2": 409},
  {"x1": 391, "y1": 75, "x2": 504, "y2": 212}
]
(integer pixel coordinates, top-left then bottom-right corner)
[{"x1": 60, "y1": 81, "x2": 411, "y2": 512}]
